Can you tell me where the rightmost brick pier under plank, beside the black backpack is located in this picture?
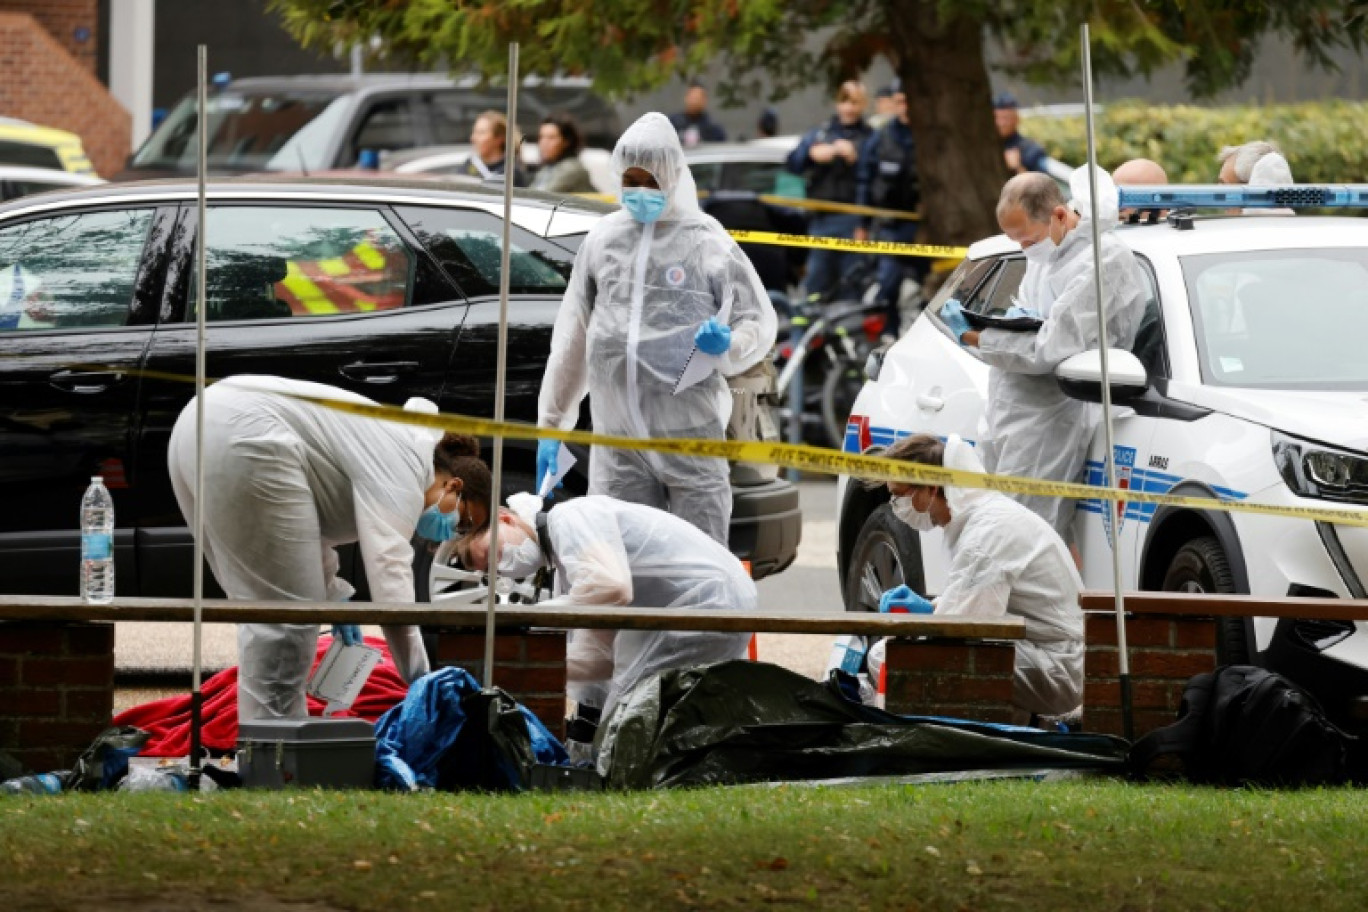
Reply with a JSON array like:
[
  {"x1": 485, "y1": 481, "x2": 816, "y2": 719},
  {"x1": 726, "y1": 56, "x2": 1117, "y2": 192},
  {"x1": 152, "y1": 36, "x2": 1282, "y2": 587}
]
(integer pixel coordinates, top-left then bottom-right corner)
[{"x1": 1083, "y1": 611, "x2": 1216, "y2": 737}]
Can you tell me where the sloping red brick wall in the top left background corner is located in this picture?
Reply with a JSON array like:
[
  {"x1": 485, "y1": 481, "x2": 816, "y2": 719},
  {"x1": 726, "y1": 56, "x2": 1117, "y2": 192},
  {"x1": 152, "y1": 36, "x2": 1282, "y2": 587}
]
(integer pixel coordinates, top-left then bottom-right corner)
[{"x1": 0, "y1": 12, "x2": 131, "y2": 176}]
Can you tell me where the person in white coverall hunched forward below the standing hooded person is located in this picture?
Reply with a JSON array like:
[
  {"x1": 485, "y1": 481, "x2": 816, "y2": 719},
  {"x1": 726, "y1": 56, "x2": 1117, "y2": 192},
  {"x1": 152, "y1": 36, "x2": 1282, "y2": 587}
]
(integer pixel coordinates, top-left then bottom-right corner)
[{"x1": 457, "y1": 495, "x2": 759, "y2": 718}]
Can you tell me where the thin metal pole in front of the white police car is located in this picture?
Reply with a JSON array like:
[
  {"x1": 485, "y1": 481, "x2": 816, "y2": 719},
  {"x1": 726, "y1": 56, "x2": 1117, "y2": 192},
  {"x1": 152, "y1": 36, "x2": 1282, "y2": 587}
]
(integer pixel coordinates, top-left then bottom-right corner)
[{"x1": 1079, "y1": 22, "x2": 1135, "y2": 740}]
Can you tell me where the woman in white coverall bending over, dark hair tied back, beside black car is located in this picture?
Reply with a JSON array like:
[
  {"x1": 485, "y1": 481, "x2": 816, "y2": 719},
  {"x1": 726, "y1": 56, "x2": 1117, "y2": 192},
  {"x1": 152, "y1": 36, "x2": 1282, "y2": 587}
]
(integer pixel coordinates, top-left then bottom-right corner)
[{"x1": 167, "y1": 376, "x2": 488, "y2": 721}]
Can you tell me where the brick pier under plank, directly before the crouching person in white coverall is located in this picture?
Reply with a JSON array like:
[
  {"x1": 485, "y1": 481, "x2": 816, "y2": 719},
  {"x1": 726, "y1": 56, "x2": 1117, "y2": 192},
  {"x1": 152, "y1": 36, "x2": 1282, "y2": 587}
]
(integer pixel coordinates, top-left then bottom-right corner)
[{"x1": 885, "y1": 640, "x2": 1016, "y2": 722}]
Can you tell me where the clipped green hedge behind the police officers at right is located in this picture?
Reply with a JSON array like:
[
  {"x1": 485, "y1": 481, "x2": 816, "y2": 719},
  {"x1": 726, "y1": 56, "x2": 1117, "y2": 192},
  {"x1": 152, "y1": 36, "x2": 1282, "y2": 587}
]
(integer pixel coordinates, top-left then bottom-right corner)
[{"x1": 1021, "y1": 101, "x2": 1368, "y2": 183}]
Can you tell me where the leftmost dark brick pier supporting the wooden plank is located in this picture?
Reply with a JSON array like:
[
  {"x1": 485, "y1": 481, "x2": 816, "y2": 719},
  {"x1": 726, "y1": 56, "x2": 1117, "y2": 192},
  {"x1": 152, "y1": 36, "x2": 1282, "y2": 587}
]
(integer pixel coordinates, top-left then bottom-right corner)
[{"x1": 0, "y1": 622, "x2": 114, "y2": 773}]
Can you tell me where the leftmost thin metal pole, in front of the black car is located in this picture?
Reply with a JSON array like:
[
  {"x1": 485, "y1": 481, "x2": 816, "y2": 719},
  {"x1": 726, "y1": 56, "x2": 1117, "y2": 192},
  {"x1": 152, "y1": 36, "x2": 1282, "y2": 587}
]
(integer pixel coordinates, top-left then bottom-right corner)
[{"x1": 187, "y1": 44, "x2": 209, "y2": 792}]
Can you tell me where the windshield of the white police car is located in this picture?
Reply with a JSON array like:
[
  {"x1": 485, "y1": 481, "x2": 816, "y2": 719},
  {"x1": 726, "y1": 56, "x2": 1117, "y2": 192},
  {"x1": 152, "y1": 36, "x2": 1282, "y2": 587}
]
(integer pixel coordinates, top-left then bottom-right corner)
[{"x1": 1182, "y1": 247, "x2": 1368, "y2": 390}]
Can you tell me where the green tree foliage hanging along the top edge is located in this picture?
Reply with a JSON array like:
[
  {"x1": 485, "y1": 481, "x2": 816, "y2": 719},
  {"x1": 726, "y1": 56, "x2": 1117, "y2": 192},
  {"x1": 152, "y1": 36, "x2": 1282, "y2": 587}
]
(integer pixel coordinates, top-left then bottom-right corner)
[{"x1": 269, "y1": 0, "x2": 1368, "y2": 103}]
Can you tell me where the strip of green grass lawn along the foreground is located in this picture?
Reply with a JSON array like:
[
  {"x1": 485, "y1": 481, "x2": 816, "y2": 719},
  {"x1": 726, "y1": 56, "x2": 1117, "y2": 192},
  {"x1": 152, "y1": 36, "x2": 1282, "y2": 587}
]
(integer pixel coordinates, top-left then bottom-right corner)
[{"x1": 0, "y1": 781, "x2": 1368, "y2": 912}]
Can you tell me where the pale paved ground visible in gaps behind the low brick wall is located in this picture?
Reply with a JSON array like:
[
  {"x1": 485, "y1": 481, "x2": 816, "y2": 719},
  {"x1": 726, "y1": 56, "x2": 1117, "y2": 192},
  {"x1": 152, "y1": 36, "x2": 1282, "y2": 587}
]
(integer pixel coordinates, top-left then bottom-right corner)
[{"x1": 115, "y1": 479, "x2": 841, "y2": 708}]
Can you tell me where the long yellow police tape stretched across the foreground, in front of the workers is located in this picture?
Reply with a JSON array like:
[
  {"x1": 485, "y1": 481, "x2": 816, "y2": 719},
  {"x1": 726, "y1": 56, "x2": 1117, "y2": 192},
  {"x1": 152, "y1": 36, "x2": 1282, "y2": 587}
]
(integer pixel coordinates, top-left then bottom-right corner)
[{"x1": 96, "y1": 364, "x2": 1368, "y2": 528}]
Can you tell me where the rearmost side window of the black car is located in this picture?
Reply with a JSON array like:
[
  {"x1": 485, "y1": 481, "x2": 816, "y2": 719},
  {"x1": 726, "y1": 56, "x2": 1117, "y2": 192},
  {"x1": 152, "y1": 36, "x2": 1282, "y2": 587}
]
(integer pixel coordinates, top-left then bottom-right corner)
[{"x1": 399, "y1": 206, "x2": 575, "y2": 297}]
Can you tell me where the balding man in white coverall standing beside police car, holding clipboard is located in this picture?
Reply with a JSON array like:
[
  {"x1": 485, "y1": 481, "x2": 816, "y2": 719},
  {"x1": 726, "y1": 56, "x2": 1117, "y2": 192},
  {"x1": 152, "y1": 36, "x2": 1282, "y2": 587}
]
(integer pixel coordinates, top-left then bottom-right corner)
[{"x1": 941, "y1": 168, "x2": 1146, "y2": 544}]
